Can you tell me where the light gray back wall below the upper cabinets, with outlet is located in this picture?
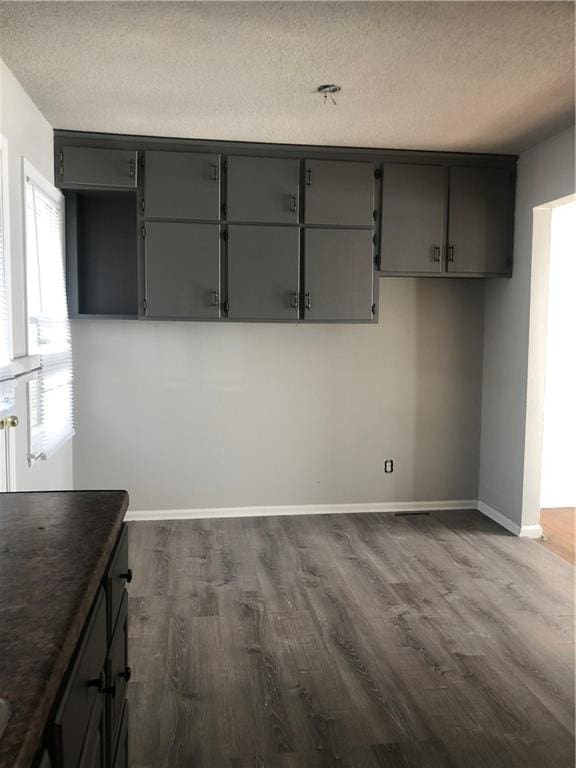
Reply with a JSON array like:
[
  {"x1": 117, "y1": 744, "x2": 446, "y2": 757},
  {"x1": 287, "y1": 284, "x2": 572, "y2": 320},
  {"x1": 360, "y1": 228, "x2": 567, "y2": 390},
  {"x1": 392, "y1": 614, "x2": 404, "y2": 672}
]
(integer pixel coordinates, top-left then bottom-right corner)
[{"x1": 73, "y1": 278, "x2": 484, "y2": 510}]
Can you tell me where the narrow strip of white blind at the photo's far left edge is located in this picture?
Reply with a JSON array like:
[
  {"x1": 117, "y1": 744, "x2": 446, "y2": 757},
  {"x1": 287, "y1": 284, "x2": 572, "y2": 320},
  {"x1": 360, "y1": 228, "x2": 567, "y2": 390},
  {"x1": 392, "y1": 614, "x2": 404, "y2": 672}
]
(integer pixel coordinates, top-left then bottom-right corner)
[{"x1": 0, "y1": 136, "x2": 15, "y2": 416}]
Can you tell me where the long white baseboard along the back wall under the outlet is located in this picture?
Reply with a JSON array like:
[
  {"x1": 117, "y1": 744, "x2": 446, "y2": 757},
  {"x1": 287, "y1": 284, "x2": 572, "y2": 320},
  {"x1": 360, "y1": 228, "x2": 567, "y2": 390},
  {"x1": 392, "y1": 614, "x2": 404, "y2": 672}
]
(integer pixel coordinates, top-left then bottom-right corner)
[{"x1": 126, "y1": 499, "x2": 477, "y2": 521}]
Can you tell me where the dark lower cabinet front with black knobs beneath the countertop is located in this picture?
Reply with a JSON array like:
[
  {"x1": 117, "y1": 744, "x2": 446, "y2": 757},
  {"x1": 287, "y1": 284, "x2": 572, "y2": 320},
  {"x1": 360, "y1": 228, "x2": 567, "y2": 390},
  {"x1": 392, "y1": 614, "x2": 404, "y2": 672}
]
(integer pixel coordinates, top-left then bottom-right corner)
[{"x1": 45, "y1": 526, "x2": 130, "y2": 768}]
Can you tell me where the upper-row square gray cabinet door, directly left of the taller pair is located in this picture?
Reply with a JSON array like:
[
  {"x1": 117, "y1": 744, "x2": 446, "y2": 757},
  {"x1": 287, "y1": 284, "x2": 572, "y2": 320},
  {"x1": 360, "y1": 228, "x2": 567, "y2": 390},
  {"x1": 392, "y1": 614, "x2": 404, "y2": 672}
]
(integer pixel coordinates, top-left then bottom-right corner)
[{"x1": 304, "y1": 160, "x2": 375, "y2": 227}]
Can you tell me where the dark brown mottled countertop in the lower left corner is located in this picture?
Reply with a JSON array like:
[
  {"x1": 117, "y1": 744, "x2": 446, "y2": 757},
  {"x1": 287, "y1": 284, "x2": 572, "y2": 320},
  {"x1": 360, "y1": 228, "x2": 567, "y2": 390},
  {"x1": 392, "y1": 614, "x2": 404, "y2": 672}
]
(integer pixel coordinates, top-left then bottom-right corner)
[{"x1": 0, "y1": 491, "x2": 128, "y2": 768}]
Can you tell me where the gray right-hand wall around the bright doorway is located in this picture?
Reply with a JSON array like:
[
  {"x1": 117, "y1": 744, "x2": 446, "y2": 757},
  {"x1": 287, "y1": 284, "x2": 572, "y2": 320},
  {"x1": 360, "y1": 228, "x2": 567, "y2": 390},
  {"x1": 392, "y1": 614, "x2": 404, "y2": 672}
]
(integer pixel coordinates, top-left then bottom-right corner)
[{"x1": 479, "y1": 128, "x2": 574, "y2": 526}]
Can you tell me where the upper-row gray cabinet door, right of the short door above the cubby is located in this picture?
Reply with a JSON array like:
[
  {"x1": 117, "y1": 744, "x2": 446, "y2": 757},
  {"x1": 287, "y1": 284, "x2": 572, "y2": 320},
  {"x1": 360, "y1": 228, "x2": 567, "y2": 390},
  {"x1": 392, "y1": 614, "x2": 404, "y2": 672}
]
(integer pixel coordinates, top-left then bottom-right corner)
[{"x1": 144, "y1": 152, "x2": 220, "y2": 221}]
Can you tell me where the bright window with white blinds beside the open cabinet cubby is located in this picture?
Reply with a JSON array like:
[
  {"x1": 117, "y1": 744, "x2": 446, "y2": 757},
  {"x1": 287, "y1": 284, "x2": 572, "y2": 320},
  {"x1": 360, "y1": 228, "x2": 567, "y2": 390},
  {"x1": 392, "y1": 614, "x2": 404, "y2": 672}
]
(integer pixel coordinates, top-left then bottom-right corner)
[{"x1": 24, "y1": 163, "x2": 74, "y2": 462}]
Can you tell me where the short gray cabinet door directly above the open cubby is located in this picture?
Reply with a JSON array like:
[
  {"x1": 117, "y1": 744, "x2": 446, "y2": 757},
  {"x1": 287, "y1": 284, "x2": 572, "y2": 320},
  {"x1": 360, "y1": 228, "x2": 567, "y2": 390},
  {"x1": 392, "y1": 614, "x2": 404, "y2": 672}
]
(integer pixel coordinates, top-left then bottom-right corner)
[{"x1": 57, "y1": 147, "x2": 138, "y2": 189}]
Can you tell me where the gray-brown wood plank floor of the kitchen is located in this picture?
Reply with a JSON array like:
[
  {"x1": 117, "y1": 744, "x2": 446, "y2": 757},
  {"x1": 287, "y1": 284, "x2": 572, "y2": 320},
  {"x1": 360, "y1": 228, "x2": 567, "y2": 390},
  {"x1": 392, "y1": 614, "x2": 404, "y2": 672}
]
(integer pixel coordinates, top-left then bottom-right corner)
[{"x1": 129, "y1": 512, "x2": 574, "y2": 768}]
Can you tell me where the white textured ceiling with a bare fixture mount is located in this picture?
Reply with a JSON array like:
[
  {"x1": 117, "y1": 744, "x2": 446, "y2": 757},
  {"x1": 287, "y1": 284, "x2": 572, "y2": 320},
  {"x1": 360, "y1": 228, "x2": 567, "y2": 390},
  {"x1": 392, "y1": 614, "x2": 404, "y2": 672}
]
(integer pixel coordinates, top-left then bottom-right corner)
[{"x1": 0, "y1": 2, "x2": 574, "y2": 152}]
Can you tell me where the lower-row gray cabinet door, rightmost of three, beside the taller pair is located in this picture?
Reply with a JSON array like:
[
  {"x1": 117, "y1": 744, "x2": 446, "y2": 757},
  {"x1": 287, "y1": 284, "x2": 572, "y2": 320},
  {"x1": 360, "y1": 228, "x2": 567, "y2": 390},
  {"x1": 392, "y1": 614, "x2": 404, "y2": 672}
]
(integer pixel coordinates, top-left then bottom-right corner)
[{"x1": 304, "y1": 229, "x2": 374, "y2": 321}]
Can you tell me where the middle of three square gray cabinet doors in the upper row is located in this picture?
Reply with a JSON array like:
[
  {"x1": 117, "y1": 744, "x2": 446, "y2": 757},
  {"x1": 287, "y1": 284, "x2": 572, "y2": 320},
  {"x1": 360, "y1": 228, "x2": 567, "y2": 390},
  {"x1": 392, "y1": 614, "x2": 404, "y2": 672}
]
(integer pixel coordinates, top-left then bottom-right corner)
[{"x1": 226, "y1": 157, "x2": 299, "y2": 224}]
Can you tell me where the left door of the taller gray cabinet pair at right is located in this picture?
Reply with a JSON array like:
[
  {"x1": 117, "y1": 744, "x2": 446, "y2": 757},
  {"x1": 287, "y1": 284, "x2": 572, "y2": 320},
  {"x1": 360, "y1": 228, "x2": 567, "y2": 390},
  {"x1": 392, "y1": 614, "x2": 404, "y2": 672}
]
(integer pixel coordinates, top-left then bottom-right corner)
[{"x1": 380, "y1": 164, "x2": 446, "y2": 273}]
